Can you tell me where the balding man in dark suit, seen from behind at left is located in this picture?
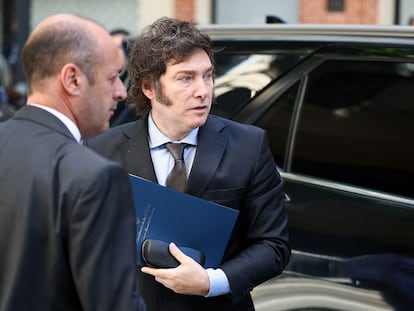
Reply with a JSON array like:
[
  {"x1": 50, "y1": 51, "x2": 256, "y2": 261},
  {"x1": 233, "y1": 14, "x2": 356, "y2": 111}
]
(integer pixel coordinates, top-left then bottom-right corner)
[{"x1": 0, "y1": 14, "x2": 145, "y2": 311}]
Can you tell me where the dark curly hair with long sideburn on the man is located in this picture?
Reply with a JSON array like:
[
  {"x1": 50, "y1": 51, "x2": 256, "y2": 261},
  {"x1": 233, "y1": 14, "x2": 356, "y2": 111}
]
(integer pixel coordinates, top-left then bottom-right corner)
[{"x1": 128, "y1": 17, "x2": 214, "y2": 117}]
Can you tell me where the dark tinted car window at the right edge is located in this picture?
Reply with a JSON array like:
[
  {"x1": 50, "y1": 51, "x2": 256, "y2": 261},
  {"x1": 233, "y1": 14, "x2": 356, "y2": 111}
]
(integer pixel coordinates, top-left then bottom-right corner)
[{"x1": 291, "y1": 60, "x2": 414, "y2": 197}]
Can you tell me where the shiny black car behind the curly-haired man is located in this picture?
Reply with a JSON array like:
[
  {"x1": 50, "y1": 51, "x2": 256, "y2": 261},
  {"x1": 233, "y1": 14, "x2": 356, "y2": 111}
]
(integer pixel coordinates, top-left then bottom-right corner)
[{"x1": 112, "y1": 24, "x2": 414, "y2": 311}]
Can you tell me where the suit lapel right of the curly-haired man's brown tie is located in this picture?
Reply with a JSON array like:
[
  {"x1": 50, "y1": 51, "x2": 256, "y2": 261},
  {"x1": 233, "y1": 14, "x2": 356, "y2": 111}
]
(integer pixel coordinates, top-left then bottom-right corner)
[{"x1": 186, "y1": 117, "x2": 227, "y2": 197}]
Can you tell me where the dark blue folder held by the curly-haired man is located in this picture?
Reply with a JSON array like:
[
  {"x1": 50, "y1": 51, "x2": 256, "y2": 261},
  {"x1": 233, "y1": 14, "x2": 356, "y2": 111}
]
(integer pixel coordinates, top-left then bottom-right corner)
[{"x1": 129, "y1": 174, "x2": 239, "y2": 268}]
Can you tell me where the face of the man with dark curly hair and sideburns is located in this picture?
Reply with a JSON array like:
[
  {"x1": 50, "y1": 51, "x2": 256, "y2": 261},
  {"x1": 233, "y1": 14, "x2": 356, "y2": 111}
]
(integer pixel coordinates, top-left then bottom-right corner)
[{"x1": 147, "y1": 50, "x2": 214, "y2": 140}]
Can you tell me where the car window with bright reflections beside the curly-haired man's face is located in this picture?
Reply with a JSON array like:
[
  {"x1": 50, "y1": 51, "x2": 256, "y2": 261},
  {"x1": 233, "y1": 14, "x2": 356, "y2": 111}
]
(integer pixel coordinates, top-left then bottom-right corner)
[{"x1": 212, "y1": 51, "x2": 302, "y2": 118}]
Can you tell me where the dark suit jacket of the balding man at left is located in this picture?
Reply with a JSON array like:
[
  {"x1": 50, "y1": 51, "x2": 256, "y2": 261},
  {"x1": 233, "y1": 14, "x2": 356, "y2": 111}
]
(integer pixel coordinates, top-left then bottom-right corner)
[{"x1": 0, "y1": 106, "x2": 144, "y2": 311}]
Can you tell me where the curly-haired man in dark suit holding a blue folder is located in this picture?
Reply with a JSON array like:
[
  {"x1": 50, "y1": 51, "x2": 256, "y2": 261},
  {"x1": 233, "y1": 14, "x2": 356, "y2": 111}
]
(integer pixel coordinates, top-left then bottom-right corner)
[{"x1": 88, "y1": 18, "x2": 290, "y2": 311}]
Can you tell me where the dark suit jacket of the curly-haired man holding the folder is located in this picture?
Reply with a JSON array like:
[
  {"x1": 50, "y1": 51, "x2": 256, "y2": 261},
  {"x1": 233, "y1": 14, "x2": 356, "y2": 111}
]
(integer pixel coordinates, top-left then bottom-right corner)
[{"x1": 88, "y1": 116, "x2": 290, "y2": 311}]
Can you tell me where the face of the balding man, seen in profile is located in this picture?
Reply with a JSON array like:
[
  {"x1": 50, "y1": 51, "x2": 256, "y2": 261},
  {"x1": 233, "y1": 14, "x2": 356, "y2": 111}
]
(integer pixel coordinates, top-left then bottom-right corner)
[{"x1": 78, "y1": 42, "x2": 127, "y2": 138}]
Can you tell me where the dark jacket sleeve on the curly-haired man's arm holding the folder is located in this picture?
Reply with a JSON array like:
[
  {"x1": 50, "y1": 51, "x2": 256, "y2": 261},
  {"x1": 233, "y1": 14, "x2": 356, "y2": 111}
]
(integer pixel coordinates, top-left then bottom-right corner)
[{"x1": 222, "y1": 130, "x2": 291, "y2": 295}]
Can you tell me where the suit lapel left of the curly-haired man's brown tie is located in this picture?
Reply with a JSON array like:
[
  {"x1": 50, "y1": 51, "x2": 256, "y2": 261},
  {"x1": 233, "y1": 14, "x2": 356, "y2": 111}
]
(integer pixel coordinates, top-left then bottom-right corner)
[{"x1": 120, "y1": 118, "x2": 157, "y2": 182}]
